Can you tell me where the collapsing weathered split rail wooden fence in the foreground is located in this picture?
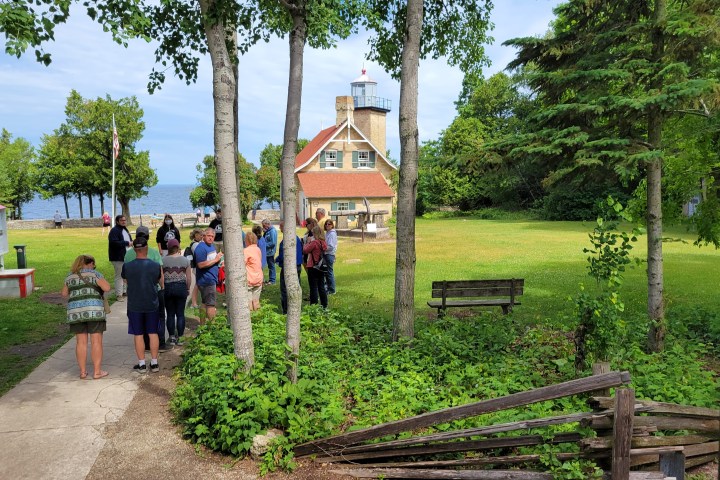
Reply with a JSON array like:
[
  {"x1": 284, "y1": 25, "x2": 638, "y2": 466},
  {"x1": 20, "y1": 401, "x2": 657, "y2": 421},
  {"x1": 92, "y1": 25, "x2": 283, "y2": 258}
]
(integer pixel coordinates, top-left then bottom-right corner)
[{"x1": 294, "y1": 372, "x2": 720, "y2": 480}]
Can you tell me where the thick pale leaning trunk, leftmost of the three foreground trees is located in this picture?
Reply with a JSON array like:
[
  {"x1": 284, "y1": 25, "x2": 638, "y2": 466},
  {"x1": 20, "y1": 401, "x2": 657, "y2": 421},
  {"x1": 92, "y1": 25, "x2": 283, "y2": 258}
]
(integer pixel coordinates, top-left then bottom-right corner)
[{"x1": 200, "y1": 0, "x2": 255, "y2": 371}]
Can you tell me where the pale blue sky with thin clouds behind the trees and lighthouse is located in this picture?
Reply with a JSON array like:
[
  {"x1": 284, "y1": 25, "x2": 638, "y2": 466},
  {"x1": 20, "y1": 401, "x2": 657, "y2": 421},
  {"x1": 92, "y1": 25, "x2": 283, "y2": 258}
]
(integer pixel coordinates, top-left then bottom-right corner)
[{"x1": 0, "y1": 0, "x2": 560, "y2": 184}]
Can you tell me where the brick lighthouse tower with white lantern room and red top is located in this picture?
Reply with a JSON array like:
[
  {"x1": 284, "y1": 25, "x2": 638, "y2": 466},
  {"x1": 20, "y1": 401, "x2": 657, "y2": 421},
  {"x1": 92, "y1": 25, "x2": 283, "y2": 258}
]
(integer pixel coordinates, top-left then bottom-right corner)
[{"x1": 350, "y1": 68, "x2": 391, "y2": 154}]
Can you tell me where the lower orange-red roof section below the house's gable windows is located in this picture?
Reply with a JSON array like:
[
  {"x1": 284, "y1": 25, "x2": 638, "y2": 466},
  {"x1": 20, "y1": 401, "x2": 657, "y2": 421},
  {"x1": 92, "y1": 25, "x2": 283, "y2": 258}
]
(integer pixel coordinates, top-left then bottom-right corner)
[{"x1": 298, "y1": 172, "x2": 395, "y2": 198}]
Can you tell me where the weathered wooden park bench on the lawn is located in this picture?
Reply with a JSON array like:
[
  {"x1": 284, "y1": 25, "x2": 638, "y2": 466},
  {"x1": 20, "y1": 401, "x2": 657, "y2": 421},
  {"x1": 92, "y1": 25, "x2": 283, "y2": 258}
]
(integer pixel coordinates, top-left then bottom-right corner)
[{"x1": 428, "y1": 278, "x2": 525, "y2": 316}]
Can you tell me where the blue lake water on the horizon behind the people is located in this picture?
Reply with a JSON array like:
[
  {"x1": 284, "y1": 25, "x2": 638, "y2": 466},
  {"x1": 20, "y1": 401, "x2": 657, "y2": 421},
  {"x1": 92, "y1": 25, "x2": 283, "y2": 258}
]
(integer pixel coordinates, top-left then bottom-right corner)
[{"x1": 22, "y1": 185, "x2": 194, "y2": 220}]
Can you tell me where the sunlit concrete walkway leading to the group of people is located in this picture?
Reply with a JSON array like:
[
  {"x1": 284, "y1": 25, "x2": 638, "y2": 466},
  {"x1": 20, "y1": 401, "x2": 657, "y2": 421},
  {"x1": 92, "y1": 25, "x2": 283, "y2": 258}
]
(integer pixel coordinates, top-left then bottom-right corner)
[{"x1": 0, "y1": 302, "x2": 142, "y2": 480}]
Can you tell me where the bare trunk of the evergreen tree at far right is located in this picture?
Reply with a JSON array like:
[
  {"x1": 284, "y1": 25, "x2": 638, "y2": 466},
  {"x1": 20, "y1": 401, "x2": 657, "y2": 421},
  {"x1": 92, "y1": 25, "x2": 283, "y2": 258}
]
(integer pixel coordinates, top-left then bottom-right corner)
[{"x1": 647, "y1": 0, "x2": 667, "y2": 352}]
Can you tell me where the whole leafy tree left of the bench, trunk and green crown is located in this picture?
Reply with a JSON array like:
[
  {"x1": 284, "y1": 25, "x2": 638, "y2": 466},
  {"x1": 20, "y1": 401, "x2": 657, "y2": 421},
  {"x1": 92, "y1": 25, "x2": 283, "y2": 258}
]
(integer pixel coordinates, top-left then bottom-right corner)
[{"x1": 367, "y1": 0, "x2": 492, "y2": 339}]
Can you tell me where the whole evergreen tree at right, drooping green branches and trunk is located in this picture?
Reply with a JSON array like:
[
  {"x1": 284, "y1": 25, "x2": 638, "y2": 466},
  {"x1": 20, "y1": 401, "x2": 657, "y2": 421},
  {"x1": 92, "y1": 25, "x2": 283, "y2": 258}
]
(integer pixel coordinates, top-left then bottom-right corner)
[{"x1": 506, "y1": 0, "x2": 720, "y2": 351}]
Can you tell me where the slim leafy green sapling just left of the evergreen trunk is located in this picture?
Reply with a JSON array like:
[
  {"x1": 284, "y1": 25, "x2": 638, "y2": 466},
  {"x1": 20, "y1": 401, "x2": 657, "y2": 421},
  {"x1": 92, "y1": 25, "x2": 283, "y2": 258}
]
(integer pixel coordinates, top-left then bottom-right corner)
[{"x1": 575, "y1": 197, "x2": 640, "y2": 372}]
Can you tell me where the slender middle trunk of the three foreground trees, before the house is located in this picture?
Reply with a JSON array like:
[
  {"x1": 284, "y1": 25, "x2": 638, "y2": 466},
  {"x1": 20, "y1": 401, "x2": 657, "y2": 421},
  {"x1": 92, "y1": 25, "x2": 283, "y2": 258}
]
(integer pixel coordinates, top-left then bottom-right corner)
[{"x1": 281, "y1": 6, "x2": 307, "y2": 383}]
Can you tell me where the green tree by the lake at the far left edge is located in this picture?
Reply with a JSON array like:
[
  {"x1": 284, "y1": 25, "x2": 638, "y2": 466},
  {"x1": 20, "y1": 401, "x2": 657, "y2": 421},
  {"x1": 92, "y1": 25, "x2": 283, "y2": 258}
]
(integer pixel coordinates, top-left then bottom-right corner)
[{"x1": 0, "y1": 128, "x2": 35, "y2": 219}]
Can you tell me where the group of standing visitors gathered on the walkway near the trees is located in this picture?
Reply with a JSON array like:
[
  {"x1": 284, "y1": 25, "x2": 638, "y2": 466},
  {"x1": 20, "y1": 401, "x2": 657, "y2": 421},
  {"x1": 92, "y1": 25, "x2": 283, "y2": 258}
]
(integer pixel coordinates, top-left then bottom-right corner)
[{"x1": 62, "y1": 208, "x2": 337, "y2": 379}]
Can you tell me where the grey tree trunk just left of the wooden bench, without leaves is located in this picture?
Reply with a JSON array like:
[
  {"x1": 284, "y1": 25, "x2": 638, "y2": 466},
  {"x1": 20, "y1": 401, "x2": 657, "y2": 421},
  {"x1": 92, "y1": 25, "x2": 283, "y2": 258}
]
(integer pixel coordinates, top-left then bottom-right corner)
[{"x1": 393, "y1": 0, "x2": 423, "y2": 341}]
